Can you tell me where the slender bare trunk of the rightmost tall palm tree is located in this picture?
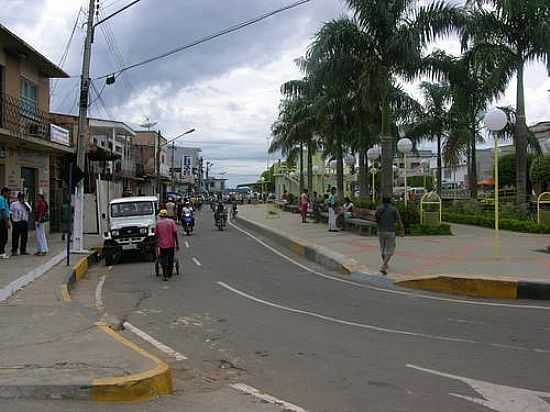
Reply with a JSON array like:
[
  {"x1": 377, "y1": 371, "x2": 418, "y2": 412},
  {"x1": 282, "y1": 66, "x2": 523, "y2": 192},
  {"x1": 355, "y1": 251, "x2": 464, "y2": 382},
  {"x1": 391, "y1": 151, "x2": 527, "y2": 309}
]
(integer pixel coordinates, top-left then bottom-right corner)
[{"x1": 514, "y1": 62, "x2": 529, "y2": 208}]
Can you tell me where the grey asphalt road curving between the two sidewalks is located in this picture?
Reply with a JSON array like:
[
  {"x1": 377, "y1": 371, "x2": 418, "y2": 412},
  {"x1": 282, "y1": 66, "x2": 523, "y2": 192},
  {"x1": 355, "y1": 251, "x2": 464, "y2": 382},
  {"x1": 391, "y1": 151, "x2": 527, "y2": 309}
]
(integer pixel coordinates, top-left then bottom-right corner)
[{"x1": 50, "y1": 211, "x2": 550, "y2": 412}]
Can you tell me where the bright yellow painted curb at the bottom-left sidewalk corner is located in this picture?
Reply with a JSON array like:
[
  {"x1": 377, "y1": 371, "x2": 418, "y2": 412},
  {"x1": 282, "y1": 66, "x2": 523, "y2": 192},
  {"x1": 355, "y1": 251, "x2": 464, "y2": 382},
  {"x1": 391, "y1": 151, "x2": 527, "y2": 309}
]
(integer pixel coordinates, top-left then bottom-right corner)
[{"x1": 90, "y1": 323, "x2": 174, "y2": 402}]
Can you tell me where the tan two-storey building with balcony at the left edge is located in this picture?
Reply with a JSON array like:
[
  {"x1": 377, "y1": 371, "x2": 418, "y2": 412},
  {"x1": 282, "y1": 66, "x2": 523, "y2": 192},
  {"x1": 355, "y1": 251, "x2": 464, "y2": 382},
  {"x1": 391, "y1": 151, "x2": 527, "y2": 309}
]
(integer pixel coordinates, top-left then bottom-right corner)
[{"x1": 0, "y1": 25, "x2": 74, "y2": 230}]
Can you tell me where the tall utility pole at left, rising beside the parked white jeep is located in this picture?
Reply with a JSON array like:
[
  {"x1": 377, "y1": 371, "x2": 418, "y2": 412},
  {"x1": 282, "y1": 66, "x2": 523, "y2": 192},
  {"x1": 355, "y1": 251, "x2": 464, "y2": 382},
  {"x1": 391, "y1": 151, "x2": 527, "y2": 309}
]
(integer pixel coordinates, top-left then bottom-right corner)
[{"x1": 73, "y1": 0, "x2": 96, "y2": 252}]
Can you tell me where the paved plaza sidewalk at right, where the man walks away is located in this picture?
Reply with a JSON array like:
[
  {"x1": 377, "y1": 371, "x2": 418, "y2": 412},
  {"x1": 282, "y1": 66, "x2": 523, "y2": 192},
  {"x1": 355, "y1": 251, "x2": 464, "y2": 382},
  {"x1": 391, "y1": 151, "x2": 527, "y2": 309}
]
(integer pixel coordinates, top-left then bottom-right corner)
[{"x1": 239, "y1": 206, "x2": 550, "y2": 300}]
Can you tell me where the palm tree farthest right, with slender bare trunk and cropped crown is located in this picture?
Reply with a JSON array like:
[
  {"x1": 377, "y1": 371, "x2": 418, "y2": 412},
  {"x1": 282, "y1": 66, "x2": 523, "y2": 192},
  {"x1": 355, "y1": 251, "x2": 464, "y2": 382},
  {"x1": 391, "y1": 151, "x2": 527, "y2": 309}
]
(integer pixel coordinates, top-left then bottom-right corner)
[{"x1": 462, "y1": 0, "x2": 550, "y2": 207}]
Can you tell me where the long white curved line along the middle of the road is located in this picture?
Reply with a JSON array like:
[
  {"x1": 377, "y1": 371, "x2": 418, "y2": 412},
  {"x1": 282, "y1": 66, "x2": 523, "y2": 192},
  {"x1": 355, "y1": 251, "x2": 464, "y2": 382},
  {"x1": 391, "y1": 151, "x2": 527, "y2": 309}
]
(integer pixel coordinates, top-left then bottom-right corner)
[{"x1": 216, "y1": 282, "x2": 550, "y2": 353}]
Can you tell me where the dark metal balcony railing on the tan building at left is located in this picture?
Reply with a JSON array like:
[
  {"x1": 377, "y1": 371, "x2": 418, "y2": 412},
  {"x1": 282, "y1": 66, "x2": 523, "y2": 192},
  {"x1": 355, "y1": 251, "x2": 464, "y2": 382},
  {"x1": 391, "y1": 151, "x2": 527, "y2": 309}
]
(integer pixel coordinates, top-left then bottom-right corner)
[{"x1": 0, "y1": 94, "x2": 50, "y2": 140}]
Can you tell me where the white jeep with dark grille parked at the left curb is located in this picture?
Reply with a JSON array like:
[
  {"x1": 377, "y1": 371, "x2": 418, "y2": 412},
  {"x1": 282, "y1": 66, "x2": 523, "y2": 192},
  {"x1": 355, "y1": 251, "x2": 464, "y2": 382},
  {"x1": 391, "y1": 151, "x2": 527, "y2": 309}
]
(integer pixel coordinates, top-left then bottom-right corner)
[{"x1": 103, "y1": 196, "x2": 158, "y2": 265}]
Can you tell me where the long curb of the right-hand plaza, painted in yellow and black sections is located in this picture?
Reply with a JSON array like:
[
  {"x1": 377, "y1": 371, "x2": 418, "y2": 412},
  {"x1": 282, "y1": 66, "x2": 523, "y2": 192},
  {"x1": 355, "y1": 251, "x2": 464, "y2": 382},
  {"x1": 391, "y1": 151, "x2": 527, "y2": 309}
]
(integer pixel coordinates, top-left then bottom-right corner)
[{"x1": 235, "y1": 215, "x2": 550, "y2": 300}]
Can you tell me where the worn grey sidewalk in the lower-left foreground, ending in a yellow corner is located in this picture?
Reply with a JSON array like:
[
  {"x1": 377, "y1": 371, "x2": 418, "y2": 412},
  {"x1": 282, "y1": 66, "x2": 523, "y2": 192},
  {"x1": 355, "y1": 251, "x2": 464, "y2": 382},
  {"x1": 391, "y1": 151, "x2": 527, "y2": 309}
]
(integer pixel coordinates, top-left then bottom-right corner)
[{"x1": 0, "y1": 259, "x2": 171, "y2": 400}]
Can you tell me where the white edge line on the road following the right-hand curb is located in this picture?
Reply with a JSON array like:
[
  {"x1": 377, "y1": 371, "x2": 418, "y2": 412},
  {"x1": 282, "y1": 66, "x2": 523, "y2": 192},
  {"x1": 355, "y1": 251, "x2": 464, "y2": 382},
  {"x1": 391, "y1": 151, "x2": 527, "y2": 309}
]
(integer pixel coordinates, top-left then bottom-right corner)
[{"x1": 229, "y1": 222, "x2": 550, "y2": 310}]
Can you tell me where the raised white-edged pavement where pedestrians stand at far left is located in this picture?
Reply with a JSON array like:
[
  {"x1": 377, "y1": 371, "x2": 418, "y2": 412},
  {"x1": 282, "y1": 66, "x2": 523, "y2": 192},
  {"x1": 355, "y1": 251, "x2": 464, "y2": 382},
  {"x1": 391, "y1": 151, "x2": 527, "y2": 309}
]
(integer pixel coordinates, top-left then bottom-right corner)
[{"x1": 0, "y1": 231, "x2": 101, "y2": 302}]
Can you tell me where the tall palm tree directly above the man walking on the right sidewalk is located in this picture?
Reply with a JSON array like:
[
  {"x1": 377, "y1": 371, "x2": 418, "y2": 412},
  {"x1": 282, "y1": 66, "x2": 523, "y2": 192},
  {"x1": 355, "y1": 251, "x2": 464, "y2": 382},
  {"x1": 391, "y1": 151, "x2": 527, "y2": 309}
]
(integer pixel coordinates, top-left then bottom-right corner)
[{"x1": 346, "y1": 0, "x2": 463, "y2": 197}]
